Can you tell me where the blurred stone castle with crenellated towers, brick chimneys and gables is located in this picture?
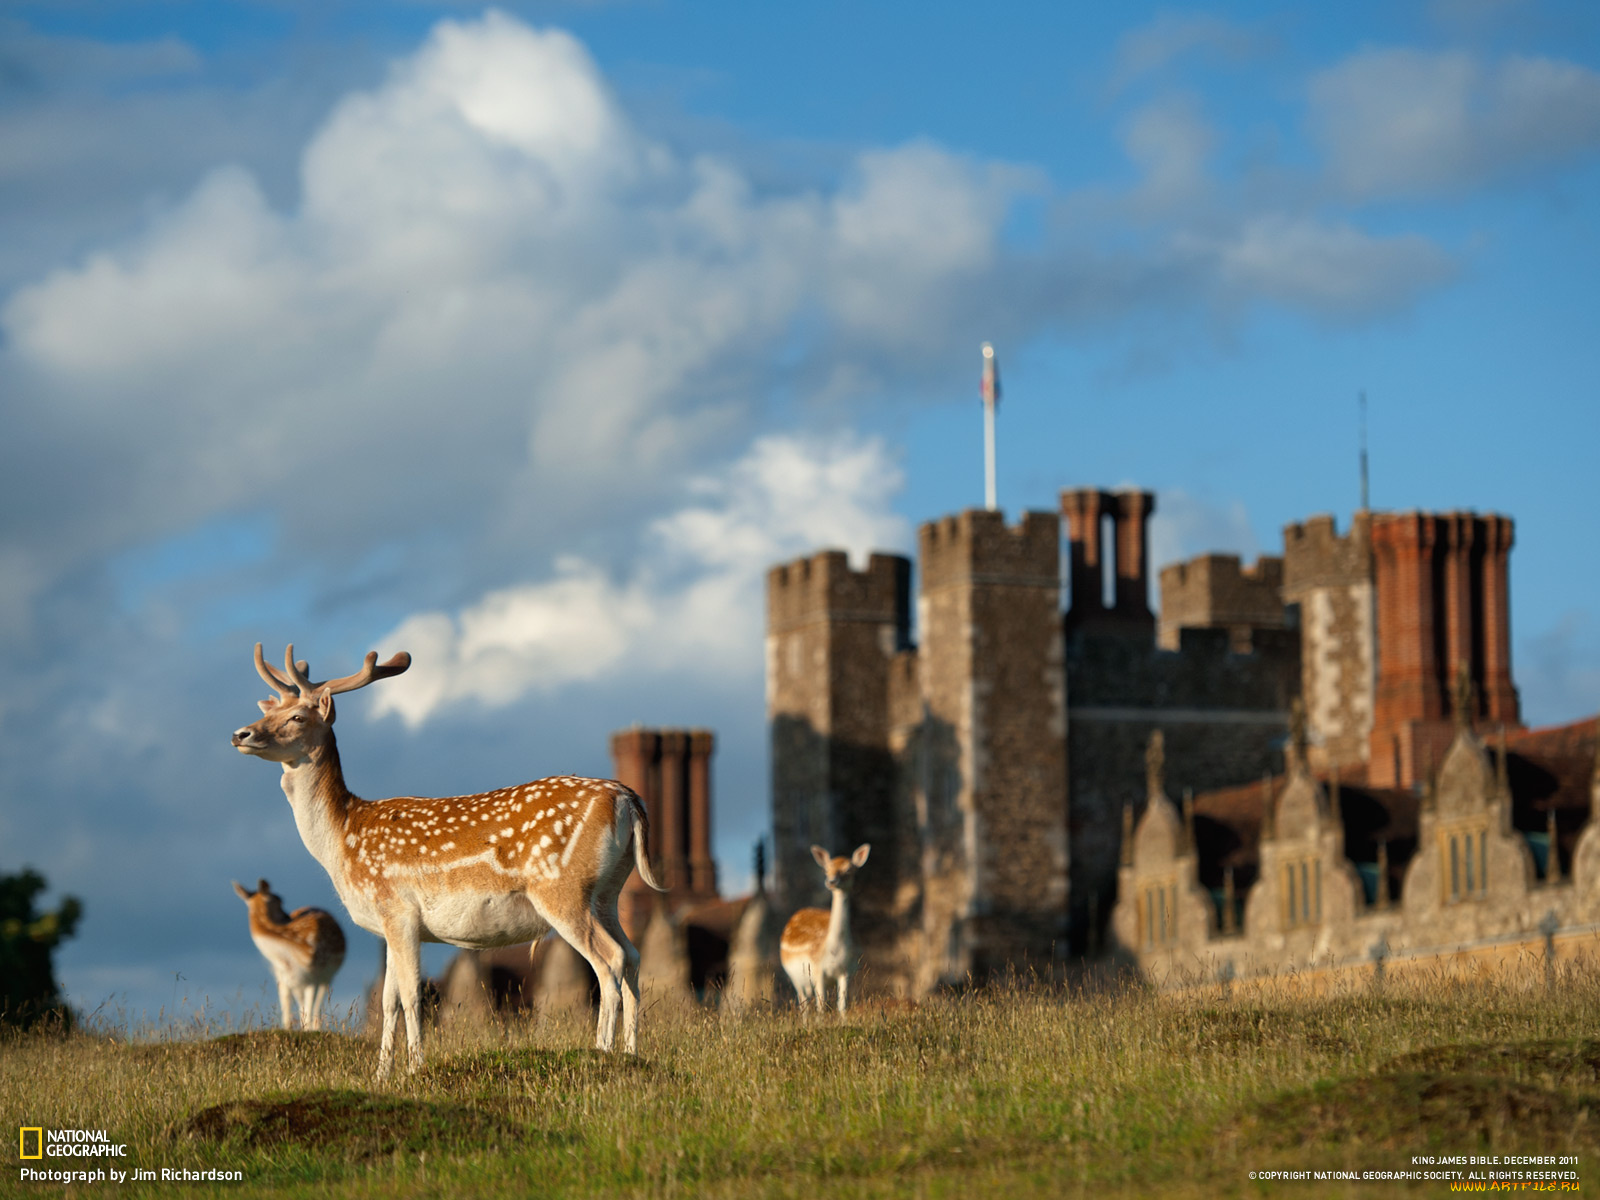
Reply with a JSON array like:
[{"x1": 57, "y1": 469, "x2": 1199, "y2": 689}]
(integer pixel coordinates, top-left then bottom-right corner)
[{"x1": 766, "y1": 488, "x2": 1600, "y2": 995}]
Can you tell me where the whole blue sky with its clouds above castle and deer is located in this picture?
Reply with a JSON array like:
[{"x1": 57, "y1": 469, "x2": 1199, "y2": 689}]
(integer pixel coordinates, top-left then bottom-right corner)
[{"x1": 0, "y1": 0, "x2": 1600, "y2": 1016}]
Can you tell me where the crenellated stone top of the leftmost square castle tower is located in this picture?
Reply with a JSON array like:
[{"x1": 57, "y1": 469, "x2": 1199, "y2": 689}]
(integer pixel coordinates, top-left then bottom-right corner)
[{"x1": 766, "y1": 550, "x2": 910, "y2": 645}]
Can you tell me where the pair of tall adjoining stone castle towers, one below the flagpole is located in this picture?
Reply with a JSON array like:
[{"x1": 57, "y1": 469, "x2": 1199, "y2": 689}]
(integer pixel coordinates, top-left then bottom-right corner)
[{"x1": 766, "y1": 510, "x2": 1067, "y2": 992}]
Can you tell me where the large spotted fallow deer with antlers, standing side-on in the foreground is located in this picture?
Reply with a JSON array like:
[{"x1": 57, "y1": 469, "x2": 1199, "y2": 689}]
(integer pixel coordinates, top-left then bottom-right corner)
[{"x1": 234, "y1": 642, "x2": 662, "y2": 1078}]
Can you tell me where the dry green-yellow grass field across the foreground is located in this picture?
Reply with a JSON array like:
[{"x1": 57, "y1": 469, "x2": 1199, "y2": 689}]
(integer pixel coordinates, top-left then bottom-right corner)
[{"x1": 0, "y1": 974, "x2": 1600, "y2": 1200}]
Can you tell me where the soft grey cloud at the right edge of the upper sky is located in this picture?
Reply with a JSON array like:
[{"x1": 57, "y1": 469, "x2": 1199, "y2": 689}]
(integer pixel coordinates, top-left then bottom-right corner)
[{"x1": 1309, "y1": 48, "x2": 1600, "y2": 197}]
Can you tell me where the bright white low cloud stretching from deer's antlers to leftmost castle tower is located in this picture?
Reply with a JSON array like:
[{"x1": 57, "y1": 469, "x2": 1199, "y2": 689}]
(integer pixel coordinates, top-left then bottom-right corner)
[{"x1": 373, "y1": 437, "x2": 909, "y2": 726}]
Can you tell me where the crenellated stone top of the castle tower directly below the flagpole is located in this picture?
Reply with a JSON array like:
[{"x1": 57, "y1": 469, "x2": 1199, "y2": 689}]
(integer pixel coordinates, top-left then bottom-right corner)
[{"x1": 918, "y1": 509, "x2": 1061, "y2": 592}]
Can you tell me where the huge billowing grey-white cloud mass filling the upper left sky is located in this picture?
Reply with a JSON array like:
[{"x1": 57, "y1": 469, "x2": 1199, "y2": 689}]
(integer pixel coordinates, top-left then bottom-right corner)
[{"x1": 0, "y1": 13, "x2": 1010, "y2": 620}]
